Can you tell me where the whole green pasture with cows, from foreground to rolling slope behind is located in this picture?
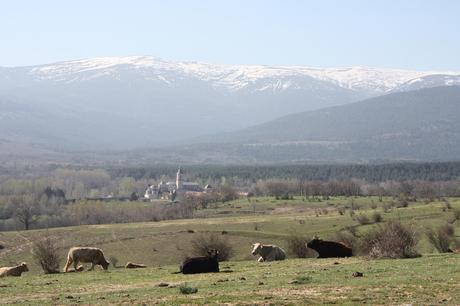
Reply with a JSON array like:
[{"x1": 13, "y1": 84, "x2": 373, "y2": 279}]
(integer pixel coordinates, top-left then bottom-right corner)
[{"x1": 0, "y1": 197, "x2": 460, "y2": 305}]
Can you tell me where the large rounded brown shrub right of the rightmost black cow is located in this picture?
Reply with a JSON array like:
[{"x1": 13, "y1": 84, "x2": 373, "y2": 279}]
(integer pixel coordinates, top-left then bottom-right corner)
[{"x1": 360, "y1": 221, "x2": 419, "y2": 258}]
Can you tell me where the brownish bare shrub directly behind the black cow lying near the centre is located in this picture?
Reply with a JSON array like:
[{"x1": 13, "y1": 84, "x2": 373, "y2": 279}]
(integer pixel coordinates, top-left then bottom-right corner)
[{"x1": 191, "y1": 233, "x2": 233, "y2": 261}]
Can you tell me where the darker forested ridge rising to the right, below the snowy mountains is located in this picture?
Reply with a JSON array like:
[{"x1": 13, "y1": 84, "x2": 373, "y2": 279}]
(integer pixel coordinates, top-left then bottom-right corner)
[{"x1": 173, "y1": 86, "x2": 460, "y2": 163}]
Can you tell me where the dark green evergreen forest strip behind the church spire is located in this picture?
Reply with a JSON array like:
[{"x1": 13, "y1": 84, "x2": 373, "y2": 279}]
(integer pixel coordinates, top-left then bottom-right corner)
[{"x1": 107, "y1": 162, "x2": 460, "y2": 182}]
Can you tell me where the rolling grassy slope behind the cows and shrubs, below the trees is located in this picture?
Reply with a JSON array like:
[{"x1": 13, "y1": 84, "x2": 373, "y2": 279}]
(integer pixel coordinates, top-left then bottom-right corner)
[{"x1": 0, "y1": 197, "x2": 460, "y2": 273}]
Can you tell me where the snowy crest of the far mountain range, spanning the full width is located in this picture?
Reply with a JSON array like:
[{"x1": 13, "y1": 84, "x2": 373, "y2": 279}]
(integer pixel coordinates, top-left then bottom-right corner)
[{"x1": 3, "y1": 56, "x2": 460, "y2": 92}]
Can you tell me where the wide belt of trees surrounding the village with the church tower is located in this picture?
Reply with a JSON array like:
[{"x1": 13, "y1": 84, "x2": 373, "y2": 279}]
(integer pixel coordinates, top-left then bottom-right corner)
[{"x1": 0, "y1": 163, "x2": 460, "y2": 230}]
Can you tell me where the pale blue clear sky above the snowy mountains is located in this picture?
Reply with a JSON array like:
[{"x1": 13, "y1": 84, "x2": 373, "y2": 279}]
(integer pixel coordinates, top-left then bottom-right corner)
[{"x1": 0, "y1": 0, "x2": 460, "y2": 71}]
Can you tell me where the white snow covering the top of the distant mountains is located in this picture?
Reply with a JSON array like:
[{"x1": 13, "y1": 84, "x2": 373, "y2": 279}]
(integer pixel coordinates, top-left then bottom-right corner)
[{"x1": 23, "y1": 56, "x2": 460, "y2": 93}]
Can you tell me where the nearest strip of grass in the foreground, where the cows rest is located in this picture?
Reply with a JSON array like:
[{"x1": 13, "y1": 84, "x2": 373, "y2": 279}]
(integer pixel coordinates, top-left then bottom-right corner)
[{"x1": 0, "y1": 254, "x2": 460, "y2": 305}]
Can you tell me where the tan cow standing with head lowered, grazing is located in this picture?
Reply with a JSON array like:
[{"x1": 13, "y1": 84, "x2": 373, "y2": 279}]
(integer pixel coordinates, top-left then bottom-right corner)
[{"x1": 64, "y1": 247, "x2": 109, "y2": 272}]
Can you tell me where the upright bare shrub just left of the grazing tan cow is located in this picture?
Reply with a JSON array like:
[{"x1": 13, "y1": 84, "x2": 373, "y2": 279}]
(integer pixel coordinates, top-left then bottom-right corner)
[{"x1": 32, "y1": 237, "x2": 60, "y2": 274}]
